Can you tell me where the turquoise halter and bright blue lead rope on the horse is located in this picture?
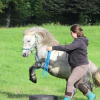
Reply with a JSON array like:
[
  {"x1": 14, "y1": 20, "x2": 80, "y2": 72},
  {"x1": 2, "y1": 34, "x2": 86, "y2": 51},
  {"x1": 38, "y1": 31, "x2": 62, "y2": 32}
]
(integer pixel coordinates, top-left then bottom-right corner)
[{"x1": 23, "y1": 34, "x2": 51, "y2": 78}]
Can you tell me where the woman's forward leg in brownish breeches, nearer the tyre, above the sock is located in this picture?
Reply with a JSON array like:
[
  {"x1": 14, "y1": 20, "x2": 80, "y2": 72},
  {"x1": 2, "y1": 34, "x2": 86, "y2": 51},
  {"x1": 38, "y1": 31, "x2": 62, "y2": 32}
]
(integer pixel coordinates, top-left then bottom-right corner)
[{"x1": 65, "y1": 64, "x2": 89, "y2": 100}]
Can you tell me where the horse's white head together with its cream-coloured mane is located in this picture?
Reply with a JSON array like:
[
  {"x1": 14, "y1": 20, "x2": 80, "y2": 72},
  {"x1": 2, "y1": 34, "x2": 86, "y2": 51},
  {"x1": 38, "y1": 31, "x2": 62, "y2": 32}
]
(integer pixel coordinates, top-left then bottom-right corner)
[{"x1": 22, "y1": 27, "x2": 59, "y2": 57}]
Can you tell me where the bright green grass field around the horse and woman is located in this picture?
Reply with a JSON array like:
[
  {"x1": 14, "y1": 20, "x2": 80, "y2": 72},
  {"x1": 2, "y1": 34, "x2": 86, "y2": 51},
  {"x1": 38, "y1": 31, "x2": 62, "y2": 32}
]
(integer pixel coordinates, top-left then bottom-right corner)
[{"x1": 0, "y1": 24, "x2": 100, "y2": 100}]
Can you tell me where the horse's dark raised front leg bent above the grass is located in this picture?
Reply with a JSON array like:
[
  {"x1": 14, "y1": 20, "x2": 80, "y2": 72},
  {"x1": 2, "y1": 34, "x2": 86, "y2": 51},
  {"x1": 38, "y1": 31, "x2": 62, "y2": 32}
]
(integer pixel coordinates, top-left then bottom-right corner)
[{"x1": 29, "y1": 62, "x2": 39, "y2": 83}]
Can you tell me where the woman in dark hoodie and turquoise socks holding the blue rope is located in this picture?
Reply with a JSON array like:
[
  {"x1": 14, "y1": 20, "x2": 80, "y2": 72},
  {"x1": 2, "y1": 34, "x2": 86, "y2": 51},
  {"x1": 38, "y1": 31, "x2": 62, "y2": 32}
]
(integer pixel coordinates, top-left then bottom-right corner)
[{"x1": 46, "y1": 24, "x2": 96, "y2": 100}]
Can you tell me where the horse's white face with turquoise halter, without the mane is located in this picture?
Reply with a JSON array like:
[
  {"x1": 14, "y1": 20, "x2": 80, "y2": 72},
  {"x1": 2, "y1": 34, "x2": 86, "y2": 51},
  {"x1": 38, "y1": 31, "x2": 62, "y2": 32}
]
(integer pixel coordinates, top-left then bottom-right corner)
[{"x1": 22, "y1": 32, "x2": 38, "y2": 57}]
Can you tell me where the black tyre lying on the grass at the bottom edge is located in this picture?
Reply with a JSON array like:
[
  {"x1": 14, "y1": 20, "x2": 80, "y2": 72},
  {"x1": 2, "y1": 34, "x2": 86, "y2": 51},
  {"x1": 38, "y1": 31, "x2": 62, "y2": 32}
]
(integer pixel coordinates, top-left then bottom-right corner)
[{"x1": 29, "y1": 95, "x2": 58, "y2": 100}]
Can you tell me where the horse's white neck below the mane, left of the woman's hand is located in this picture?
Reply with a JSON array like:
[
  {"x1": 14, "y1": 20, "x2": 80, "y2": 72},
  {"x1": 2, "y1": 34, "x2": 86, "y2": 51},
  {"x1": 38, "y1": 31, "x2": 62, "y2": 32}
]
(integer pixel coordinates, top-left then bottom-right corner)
[{"x1": 36, "y1": 44, "x2": 47, "y2": 60}]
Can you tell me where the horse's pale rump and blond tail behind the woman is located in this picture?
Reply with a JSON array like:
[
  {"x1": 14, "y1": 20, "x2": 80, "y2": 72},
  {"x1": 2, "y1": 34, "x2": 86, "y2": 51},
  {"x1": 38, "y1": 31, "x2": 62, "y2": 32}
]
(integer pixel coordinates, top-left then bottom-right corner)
[{"x1": 89, "y1": 61, "x2": 100, "y2": 87}]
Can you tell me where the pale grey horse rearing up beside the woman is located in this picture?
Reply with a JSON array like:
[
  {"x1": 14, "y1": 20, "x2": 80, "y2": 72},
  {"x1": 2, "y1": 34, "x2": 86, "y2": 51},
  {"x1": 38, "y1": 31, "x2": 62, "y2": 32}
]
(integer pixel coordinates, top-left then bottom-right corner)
[{"x1": 22, "y1": 27, "x2": 100, "y2": 96}]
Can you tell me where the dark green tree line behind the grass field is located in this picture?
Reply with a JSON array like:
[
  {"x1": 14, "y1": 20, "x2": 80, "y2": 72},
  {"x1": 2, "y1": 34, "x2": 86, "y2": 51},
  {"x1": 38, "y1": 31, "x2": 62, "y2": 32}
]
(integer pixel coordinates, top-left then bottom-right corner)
[{"x1": 0, "y1": 0, "x2": 100, "y2": 27}]
